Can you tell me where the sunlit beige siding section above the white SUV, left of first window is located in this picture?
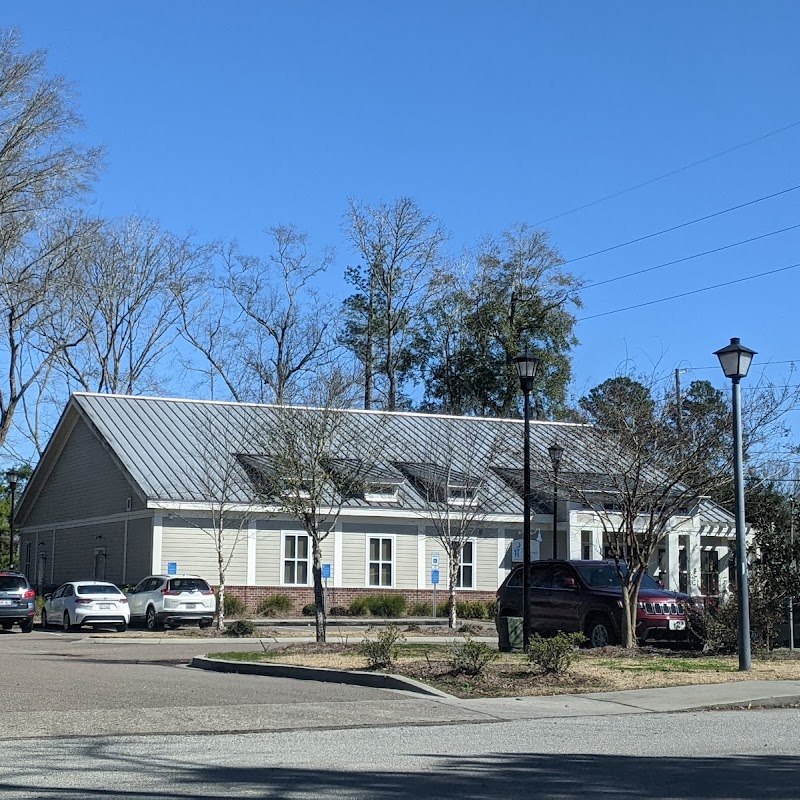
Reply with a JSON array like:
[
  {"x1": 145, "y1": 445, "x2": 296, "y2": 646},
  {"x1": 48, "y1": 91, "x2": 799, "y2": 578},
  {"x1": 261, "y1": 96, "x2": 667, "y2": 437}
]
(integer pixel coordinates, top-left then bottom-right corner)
[{"x1": 161, "y1": 520, "x2": 247, "y2": 585}]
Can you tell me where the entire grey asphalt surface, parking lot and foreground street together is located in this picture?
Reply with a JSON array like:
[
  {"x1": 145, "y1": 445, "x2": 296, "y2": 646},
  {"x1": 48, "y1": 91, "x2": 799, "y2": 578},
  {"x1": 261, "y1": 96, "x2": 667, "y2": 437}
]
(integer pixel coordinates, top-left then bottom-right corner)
[{"x1": 0, "y1": 631, "x2": 800, "y2": 800}]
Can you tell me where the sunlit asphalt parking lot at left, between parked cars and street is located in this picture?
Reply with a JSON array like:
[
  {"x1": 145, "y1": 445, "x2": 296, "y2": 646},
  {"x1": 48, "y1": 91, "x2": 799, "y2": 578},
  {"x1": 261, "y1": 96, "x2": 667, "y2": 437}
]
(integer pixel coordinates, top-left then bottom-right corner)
[{"x1": 0, "y1": 626, "x2": 484, "y2": 738}]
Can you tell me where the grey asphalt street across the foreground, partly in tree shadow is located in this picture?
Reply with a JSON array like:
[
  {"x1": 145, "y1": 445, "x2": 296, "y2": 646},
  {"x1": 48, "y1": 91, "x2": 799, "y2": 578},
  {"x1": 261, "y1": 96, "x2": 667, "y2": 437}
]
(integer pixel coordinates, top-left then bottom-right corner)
[{"x1": 0, "y1": 710, "x2": 800, "y2": 800}]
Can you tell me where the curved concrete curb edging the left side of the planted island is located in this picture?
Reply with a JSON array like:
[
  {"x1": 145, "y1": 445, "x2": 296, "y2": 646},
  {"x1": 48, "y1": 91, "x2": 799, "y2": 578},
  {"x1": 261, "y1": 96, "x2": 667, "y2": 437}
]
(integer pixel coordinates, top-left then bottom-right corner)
[{"x1": 189, "y1": 656, "x2": 455, "y2": 699}]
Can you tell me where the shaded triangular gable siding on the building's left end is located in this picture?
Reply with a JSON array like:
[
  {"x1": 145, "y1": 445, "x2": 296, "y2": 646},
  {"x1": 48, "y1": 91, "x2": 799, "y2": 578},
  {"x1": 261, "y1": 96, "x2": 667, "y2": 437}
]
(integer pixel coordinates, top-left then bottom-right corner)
[{"x1": 20, "y1": 420, "x2": 142, "y2": 527}]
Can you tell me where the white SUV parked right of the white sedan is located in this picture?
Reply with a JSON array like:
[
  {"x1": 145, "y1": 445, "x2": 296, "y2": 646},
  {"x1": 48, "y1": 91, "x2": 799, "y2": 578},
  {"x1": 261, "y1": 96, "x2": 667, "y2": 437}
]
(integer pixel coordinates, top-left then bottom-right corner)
[{"x1": 128, "y1": 575, "x2": 217, "y2": 631}]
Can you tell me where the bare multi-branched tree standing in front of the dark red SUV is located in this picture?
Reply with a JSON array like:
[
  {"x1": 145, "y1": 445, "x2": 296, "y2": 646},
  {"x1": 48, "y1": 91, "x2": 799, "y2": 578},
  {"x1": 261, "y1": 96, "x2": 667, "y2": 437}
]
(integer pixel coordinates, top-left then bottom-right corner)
[{"x1": 564, "y1": 376, "x2": 797, "y2": 647}]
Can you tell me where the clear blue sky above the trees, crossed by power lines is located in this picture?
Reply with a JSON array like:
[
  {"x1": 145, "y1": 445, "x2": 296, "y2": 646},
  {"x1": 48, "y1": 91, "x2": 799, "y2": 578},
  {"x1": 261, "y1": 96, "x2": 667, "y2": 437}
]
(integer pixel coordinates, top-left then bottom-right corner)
[{"x1": 7, "y1": 0, "x2": 800, "y2": 406}]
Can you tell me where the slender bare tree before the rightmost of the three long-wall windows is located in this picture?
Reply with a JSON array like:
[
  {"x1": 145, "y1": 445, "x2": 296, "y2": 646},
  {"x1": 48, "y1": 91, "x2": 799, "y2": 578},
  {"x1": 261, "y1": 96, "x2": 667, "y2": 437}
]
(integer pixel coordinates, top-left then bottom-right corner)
[{"x1": 406, "y1": 418, "x2": 503, "y2": 628}]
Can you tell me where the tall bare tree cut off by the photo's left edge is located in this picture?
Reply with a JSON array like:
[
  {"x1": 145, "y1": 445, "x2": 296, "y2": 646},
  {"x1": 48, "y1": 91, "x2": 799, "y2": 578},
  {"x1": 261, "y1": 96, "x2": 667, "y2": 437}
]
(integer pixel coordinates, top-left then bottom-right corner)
[{"x1": 0, "y1": 29, "x2": 101, "y2": 454}]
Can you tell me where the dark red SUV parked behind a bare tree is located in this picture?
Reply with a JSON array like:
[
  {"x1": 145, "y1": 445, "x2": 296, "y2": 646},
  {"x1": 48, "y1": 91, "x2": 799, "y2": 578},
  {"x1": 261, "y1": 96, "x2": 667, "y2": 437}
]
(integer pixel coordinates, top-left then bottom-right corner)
[{"x1": 497, "y1": 561, "x2": 687, "y2": 647}]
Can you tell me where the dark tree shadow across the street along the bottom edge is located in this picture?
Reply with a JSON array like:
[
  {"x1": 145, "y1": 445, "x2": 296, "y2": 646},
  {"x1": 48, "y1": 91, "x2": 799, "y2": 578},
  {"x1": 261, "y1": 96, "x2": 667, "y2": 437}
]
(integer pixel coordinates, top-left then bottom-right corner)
[{"x1": 0, "y1": 742, "x2": 800, "y2": 800}]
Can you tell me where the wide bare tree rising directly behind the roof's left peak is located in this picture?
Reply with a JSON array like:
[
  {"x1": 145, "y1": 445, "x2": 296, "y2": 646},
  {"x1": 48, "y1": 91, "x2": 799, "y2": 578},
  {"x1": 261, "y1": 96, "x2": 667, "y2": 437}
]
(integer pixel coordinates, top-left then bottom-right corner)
[{"x1": 52, "y1": 216, "x2": 203, "y2": 394}]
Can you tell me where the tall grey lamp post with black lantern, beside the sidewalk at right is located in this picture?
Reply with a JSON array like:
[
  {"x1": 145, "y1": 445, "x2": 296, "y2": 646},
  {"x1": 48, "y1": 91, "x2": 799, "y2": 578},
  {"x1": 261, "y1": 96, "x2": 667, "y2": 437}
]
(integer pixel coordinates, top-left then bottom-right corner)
[{"x1": 714, "y1": 337, "x2": 756, "y2": 672}]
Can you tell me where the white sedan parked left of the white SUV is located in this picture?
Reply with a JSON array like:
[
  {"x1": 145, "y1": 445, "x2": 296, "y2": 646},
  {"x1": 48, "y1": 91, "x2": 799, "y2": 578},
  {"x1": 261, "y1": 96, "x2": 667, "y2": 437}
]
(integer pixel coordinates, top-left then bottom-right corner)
[{"x1": 42, "y1": 581, "x2": 131, "y2": 633}]
